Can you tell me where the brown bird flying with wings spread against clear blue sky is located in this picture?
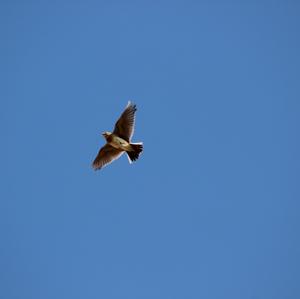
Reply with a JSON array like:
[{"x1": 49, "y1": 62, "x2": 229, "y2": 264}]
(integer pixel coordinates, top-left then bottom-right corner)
[{"x1": 92, "y1": 101, "x2": 143, "y2": 170}]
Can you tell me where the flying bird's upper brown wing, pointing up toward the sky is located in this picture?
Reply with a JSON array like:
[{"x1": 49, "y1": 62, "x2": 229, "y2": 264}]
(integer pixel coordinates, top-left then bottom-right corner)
[{"x1": 113, "y1": 101, "x2": 136, "y2": 142}]
